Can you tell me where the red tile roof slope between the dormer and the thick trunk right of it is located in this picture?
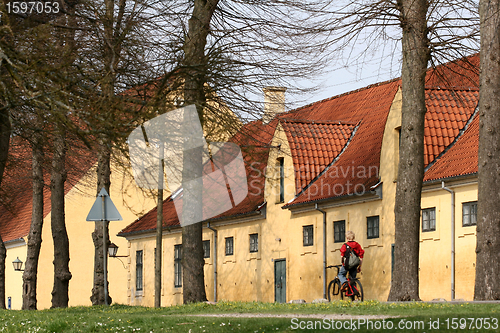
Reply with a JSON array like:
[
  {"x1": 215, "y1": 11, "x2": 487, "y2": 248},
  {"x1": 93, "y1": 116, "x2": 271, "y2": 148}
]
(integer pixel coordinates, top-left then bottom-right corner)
[{"x1": 283, "y1": 80, "x2": 400, "y2": 207}]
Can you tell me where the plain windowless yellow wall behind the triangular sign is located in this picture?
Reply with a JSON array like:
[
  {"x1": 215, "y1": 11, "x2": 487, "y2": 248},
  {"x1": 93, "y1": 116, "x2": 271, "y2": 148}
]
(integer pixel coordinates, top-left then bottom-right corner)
[{"x1": 37, "y1": 161, "x2": 155, "y2": 309}]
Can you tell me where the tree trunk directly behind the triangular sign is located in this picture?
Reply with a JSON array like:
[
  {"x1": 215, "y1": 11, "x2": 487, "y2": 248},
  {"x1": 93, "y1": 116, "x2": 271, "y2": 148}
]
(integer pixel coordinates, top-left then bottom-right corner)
[{"x1": 90, "y1": 141, "x2": 112, "y2": 305}]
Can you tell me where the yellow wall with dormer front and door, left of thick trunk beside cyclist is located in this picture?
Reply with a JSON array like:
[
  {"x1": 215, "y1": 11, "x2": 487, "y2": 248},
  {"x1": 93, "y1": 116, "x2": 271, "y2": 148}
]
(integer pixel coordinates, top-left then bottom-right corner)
[{"x1": 124, "y1": 93, "x2": 401, "y2": 305}]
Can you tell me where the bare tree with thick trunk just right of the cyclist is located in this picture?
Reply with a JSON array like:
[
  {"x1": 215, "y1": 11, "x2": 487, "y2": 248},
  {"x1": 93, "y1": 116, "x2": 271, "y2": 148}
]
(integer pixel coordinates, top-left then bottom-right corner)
[{"x1": 304, "y1": 0, "x2": 478, "y2": 301}]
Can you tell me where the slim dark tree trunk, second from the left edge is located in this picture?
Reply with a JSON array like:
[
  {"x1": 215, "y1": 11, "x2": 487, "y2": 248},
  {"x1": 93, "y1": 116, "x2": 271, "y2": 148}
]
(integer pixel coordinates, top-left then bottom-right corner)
[{"x1": 22, "y1": 133, "x2": 44, "y2": 310}]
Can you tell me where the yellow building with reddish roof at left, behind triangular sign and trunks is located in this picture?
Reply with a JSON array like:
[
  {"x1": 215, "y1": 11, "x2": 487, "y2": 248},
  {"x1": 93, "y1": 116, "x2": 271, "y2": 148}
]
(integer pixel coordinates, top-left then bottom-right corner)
[{"x1": 0, "y1": 80, "x2": 240, "y2": 309}]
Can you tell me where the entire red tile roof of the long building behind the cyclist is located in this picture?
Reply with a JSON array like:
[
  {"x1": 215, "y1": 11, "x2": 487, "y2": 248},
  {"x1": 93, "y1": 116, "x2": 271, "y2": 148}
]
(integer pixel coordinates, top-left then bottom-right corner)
[{"x1": 121, "y1": 55, "x2": 479, "y2": 231}]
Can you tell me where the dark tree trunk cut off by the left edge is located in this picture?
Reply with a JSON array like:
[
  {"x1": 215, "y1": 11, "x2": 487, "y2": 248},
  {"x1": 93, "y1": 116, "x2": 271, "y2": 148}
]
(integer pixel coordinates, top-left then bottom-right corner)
[{"x1": 0, "y1": 97, "x2": 11, "y2": 309}]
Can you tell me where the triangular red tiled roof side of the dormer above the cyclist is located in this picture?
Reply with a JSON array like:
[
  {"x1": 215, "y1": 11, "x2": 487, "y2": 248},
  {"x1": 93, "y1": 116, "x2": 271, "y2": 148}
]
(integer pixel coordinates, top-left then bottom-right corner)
[{"x1": 281, "y1": 118, "x2": 357, "y2": 193}]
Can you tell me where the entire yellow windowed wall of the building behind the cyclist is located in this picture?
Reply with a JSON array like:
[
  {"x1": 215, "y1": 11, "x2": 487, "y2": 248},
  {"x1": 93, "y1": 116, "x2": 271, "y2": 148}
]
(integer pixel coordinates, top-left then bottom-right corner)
[{"x1": 121, "y1": 87, "x2": 477, "y2": 306}]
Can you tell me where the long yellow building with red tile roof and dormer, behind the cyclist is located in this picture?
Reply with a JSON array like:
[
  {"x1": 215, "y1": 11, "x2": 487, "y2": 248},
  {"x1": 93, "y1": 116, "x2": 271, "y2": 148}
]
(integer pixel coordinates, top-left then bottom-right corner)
[{"x1": 119, "y1": 57, "x2": 478, "y2": 306}]
